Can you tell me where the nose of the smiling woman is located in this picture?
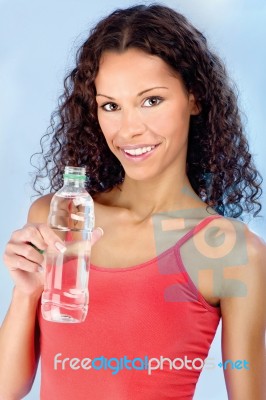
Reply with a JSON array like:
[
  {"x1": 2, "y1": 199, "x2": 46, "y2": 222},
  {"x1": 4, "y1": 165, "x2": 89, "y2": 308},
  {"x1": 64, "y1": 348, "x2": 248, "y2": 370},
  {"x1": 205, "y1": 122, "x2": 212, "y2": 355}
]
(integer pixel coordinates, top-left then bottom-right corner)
[{"x1": 119, "y1": 108, "x2": 146, "y2": 138}]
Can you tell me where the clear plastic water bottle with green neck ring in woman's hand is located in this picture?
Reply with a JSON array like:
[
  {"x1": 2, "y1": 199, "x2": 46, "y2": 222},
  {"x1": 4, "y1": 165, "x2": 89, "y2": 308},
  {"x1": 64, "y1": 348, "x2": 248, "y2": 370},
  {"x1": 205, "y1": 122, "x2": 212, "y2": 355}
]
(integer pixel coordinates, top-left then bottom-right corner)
[{"x1": 41, "y1": 167, "x2": 94, "y2": 323}]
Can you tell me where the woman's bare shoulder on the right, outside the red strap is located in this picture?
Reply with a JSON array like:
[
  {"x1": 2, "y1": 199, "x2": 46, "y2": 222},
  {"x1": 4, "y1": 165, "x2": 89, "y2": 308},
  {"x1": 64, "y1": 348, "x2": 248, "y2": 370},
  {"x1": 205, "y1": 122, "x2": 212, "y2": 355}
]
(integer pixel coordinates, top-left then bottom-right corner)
[{"x1": 193, "y1": 217, "x2": 266, "y2": 302}]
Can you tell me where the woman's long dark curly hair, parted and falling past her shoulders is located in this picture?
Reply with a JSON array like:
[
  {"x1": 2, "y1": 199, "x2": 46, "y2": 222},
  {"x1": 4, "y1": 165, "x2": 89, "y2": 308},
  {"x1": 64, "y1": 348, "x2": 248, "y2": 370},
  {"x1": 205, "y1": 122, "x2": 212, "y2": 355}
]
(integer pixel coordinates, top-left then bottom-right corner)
[{"x1": 33, "y1": 4, "x2": 262, "y2": 218}]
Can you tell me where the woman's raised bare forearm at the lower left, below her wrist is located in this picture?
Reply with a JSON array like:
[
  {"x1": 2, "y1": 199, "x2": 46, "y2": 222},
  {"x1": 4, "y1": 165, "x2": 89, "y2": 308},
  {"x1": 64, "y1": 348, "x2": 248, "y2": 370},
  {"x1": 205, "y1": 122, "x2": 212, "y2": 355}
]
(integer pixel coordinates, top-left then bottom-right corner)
[{"x1": 0, "y1": 289, "x2": 38, "y2": 400}]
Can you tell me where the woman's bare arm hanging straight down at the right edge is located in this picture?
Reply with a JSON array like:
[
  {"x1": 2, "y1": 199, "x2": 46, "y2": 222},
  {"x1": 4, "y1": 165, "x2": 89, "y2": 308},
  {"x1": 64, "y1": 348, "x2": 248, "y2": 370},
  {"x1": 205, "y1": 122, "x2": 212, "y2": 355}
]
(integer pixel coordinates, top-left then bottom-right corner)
[{"x1": 221, "y1": 230, "x2": 266, "y2": 400}]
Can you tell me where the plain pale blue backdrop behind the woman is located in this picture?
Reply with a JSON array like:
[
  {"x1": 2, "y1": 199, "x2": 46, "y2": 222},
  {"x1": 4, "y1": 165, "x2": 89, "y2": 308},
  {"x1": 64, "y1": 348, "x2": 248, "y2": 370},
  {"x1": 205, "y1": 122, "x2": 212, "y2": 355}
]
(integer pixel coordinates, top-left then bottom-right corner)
[{"x1": 0, "y1": 0, "x2": 266, "y2": 400}]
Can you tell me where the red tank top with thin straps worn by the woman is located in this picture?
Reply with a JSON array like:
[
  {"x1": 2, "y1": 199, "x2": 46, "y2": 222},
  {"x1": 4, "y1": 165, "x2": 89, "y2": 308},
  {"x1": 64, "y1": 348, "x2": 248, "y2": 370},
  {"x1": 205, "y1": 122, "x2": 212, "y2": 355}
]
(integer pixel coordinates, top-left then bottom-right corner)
[{"x1": 38, "y1": 216, "x2": 221, "y2": 400}]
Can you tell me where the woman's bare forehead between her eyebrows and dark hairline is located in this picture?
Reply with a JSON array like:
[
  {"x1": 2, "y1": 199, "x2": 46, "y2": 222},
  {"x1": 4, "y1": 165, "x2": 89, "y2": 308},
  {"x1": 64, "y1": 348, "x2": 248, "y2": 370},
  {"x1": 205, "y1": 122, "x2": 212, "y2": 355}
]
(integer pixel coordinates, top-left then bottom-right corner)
[{"x1": 95, "y1": 49, "x2": 177, "y2": 88}]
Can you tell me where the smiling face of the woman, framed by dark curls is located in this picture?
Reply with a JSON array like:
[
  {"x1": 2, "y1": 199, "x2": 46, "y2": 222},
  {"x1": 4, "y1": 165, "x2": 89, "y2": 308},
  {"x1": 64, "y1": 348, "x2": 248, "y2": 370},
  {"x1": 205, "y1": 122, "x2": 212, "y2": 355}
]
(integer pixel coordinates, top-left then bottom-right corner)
[{"x1": 95, "y1": 49, "x2": 198, "y2": 180}]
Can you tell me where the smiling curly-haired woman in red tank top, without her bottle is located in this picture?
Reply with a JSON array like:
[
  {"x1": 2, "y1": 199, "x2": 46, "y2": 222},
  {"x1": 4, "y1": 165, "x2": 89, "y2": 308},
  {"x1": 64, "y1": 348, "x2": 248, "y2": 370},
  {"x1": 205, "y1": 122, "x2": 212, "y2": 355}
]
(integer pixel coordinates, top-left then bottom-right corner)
[{"x1": 0, "y1": 5, "x2": 266, "y2": 400}]
